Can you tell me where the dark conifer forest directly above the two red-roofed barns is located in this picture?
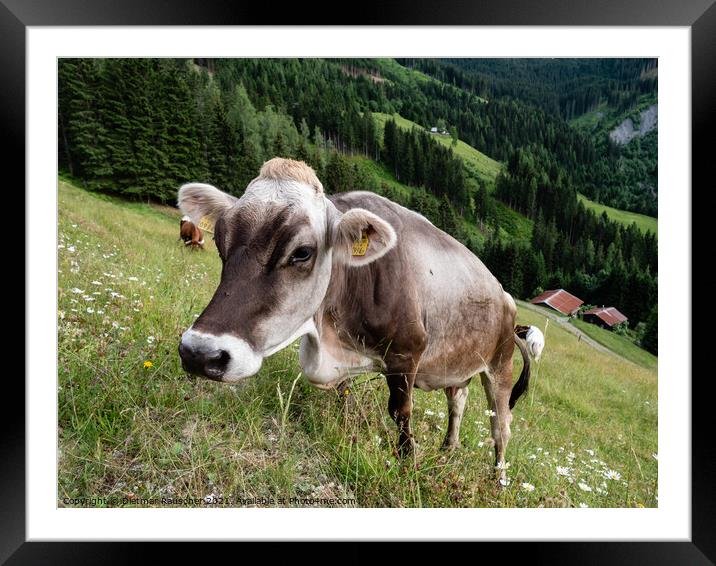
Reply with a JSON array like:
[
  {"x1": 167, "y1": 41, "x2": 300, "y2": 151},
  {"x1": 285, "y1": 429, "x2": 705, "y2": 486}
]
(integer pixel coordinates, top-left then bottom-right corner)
[{"x1": 492, "y1": 146, "x2": 658, "y2": 336}]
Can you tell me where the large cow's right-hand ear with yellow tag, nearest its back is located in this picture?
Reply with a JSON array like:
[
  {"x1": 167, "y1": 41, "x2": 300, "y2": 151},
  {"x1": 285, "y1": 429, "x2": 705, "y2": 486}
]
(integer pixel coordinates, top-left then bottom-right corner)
[{"x1": 333, "y1": 208, "x2": 398, "y2": 266}]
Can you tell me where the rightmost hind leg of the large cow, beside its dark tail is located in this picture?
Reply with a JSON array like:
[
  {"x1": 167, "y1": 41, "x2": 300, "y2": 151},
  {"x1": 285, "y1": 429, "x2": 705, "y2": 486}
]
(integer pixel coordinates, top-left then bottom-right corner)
[{"x1": 480, "y1": 366, "x2": 512, "y2": 486}]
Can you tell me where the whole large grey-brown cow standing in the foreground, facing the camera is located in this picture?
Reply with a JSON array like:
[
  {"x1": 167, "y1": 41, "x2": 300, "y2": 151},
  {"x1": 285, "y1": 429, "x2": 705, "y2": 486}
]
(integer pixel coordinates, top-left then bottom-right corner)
[{"x1": 178, "y1": 158, "x2": 530, "y2": 485}]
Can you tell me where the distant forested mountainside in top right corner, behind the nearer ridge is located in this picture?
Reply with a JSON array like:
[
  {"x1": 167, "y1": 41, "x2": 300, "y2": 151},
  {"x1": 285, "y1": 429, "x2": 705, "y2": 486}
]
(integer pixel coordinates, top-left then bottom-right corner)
[{"x1": 399, "y1": 58, "x2": 658, "y2": 216}]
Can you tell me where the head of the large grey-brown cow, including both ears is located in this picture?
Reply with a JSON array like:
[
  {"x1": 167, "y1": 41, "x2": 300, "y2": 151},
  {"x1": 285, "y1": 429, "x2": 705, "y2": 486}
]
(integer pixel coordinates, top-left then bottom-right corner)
[{"x1": 179, "y1": 158, "x2": 396, "y2": 382}]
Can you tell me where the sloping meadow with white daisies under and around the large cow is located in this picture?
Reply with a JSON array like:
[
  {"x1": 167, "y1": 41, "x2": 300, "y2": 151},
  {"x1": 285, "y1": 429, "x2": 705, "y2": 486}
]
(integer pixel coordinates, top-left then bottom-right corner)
[{"x1": 58, "y1": 183, "x2": 657, "y2": 507}]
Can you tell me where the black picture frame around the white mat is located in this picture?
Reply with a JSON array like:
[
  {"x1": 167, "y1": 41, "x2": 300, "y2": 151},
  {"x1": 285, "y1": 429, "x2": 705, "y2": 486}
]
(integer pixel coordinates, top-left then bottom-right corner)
[{"x1": 7, "y1": 0, "x2": 716, "y2": 564}]
